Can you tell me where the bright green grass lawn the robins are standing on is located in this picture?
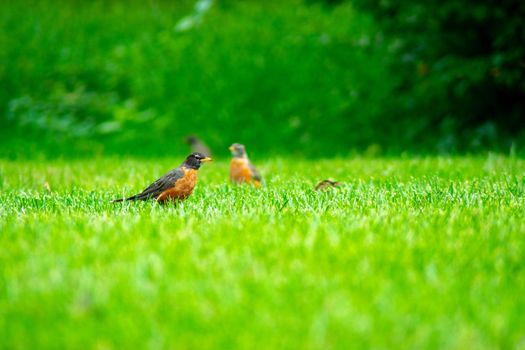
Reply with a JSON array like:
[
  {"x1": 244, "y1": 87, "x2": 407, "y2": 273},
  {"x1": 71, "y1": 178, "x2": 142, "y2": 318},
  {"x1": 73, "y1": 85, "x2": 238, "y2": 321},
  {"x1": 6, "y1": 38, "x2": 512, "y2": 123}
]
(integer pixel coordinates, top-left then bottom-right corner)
[{"x1": 0, "y1": 155, "x2": 525, "y2": 349}]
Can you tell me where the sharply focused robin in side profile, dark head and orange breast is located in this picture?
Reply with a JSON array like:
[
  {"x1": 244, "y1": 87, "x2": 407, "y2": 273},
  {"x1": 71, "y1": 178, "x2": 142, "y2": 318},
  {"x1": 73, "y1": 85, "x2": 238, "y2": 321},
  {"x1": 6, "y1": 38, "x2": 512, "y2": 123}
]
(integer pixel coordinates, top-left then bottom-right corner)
[{"x1": 113, "y1": 152, "x2": 211, "y2": 203}]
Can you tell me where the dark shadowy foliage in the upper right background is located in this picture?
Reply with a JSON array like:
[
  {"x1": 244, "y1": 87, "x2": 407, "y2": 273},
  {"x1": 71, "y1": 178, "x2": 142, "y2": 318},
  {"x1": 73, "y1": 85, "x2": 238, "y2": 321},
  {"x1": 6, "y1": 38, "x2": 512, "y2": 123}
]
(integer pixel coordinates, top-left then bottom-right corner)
[{"x1": 325, "y1": 0, "x2": 525, "y2": 150}]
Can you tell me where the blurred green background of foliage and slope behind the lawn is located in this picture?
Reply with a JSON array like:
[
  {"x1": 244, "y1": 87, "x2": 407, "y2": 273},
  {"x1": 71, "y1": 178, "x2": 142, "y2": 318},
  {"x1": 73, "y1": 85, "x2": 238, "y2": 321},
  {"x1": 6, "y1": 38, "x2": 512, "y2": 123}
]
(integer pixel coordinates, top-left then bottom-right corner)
[{"x1": 0, "y1": 0, "x2": 525, "y2": 158}]
